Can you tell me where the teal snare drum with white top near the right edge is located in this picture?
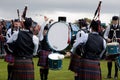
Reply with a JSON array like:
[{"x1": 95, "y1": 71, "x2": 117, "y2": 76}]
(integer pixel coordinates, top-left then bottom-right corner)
[{"x1": 107, "y1": 42, "x2": 120, "y2": 55}]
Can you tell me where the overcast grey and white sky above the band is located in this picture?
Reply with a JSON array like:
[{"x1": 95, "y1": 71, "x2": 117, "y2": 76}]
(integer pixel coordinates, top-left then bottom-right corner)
[{"x1": 0, "y1": 0, "x2": 120, "y2": 23}]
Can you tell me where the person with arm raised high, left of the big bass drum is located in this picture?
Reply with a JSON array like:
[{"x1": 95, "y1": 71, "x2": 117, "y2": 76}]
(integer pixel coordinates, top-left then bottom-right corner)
[{"x1": 38, "y1": 17, "x2": 52, "y2": 80}]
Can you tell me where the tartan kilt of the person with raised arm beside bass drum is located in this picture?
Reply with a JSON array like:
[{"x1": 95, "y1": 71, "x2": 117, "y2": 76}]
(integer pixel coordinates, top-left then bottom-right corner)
[{"x1": 37, "y1": 50, "x2": 51, "y2": 67}]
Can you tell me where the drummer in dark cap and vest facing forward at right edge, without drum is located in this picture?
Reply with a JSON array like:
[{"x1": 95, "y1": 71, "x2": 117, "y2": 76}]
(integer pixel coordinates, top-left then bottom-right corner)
[{"x1": 104, "y1": 16, "x2": 120, "y2": 79}]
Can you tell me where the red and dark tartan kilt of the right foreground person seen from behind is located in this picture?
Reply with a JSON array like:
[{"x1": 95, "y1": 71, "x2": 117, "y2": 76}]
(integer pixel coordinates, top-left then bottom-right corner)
[{"x1": 77, "y1": 59, "x2": 102, "y2": 80}]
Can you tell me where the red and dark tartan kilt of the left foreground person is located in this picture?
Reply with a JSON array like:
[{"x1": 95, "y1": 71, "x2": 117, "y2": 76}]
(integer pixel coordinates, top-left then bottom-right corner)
[{"x1": 12, "y1": 59, "x2": 34, "y2": 80}]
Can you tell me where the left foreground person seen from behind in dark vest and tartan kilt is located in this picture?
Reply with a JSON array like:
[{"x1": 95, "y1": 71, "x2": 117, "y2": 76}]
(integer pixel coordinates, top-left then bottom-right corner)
[{"x1": 7, "y1": 18, "x2": 39, "y2": 80}]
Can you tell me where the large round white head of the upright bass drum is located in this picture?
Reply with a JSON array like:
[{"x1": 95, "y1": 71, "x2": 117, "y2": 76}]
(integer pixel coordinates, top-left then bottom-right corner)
[{"x1": 47, "y1": 22, "x2": 71, "y2": 51}]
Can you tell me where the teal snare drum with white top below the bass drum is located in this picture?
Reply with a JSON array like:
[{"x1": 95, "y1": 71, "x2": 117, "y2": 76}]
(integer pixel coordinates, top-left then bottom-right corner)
[{"x1": 48, "y1": 53, "x2": 64, "y2": 70}]
